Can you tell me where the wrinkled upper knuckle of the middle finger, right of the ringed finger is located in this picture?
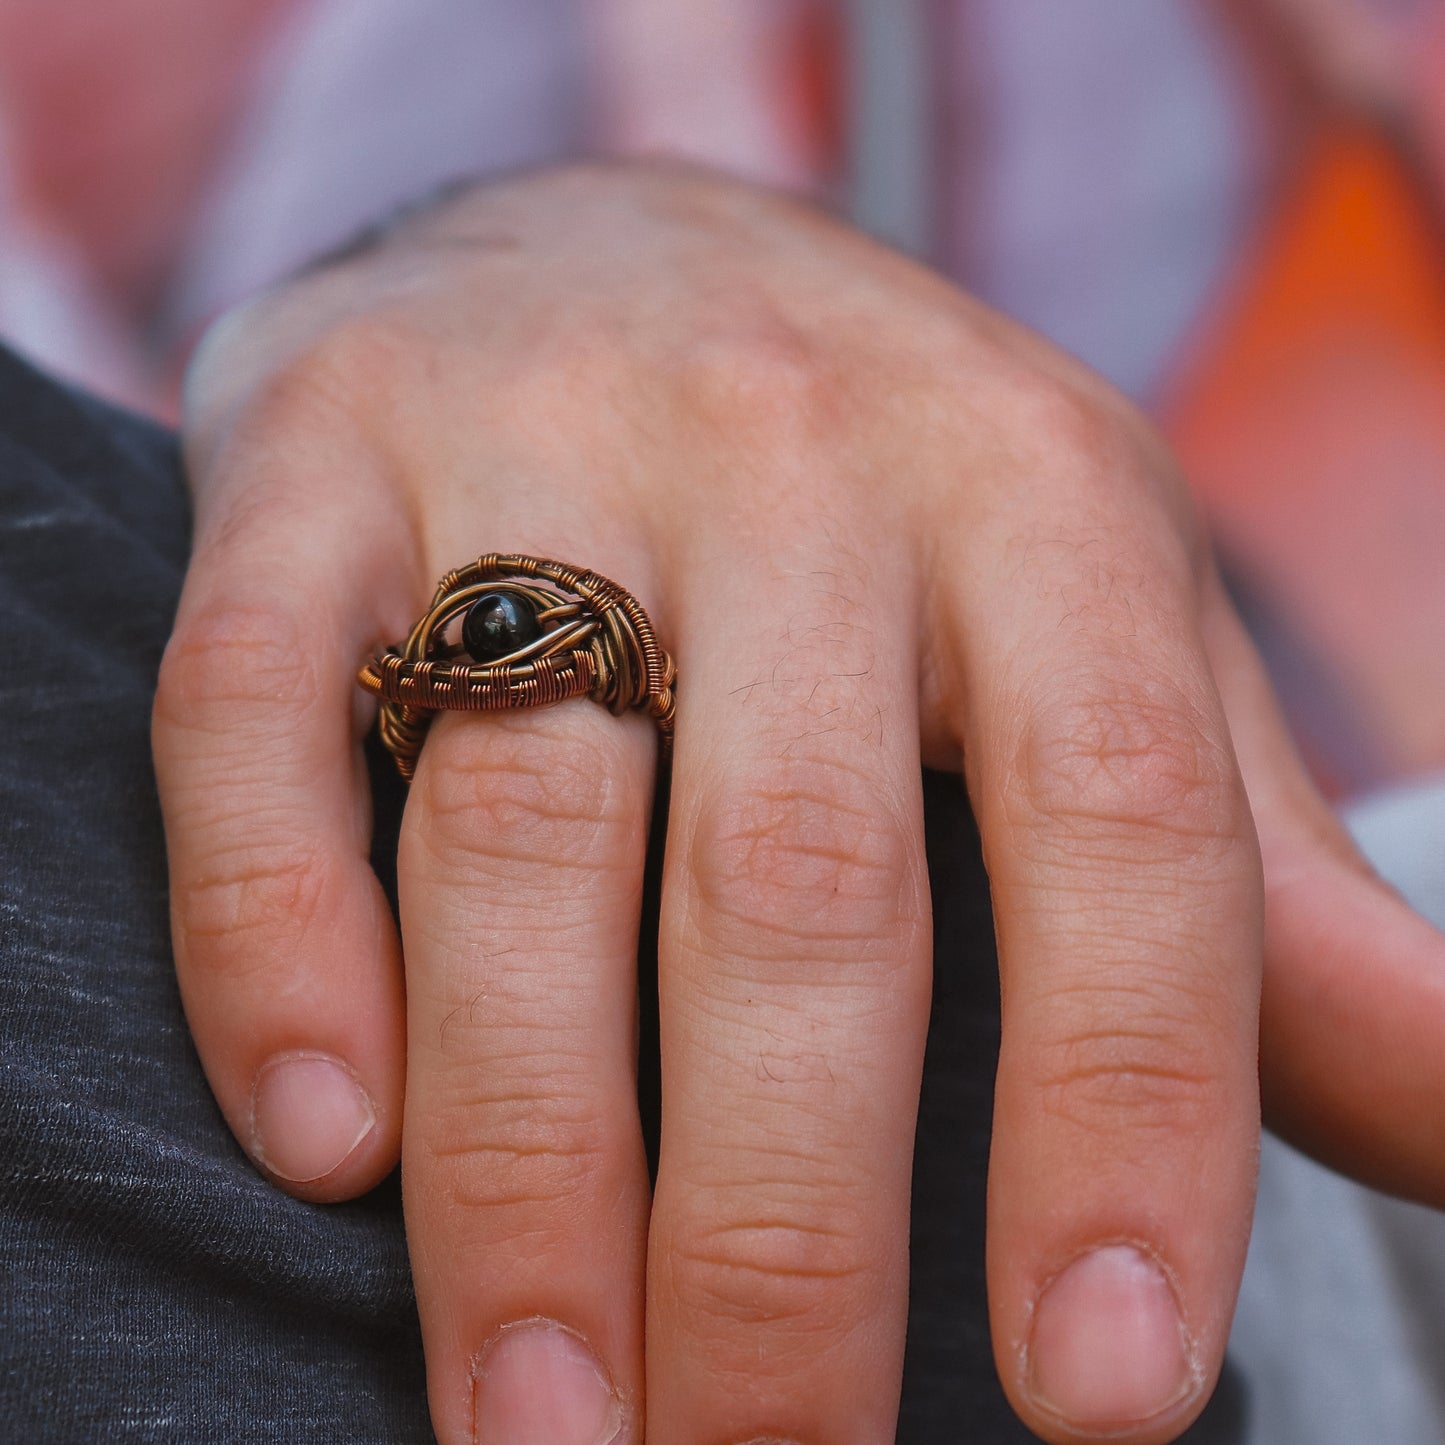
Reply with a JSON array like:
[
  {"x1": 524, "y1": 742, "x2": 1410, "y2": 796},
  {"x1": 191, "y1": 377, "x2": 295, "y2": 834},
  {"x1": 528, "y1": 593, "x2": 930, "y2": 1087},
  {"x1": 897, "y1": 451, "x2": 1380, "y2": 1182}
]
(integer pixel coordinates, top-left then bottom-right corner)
[{"x1": 692, "y1": 762, "x2": 923, "y2": 962}]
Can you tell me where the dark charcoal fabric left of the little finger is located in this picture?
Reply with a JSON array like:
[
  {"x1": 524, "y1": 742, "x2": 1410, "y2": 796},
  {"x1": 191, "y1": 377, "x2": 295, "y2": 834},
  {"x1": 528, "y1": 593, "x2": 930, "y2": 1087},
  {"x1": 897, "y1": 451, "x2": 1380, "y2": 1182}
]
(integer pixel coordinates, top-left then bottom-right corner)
[{"x1": 0, "y1": 350, "x2": 432, "y2": 1445}]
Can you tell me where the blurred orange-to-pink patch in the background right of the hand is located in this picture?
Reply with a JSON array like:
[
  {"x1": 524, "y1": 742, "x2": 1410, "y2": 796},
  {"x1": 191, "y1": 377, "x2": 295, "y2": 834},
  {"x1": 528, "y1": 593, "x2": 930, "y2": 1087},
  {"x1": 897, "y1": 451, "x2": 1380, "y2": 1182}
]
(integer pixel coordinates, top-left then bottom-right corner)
[{"x1": 1163, "y1": 123, "x2": 1445, "y2": 773}]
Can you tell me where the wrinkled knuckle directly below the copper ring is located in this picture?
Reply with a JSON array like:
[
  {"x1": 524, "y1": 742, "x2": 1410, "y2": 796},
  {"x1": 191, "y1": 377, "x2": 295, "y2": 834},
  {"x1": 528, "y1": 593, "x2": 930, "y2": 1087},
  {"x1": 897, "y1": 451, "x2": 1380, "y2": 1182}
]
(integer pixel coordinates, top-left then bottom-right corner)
[{"x1": 418, "y1": 717, "x2": 643, "y2": 887}]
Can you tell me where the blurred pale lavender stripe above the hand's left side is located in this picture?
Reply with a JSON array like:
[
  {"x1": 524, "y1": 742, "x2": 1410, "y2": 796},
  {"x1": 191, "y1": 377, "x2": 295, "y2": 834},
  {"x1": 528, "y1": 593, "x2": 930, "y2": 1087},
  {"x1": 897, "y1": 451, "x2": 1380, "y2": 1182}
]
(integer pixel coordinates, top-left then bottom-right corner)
[{"x1": 163, "y1": 0, "x2": 588, "y2": 348}]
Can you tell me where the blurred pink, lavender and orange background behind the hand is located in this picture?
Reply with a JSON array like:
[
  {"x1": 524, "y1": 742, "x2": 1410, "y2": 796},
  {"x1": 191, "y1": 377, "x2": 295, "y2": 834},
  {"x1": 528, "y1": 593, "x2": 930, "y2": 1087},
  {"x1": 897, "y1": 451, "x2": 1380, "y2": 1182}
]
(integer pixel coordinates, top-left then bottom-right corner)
[{"x1": 0, "y1": 0, "x2": 1445, "y2": 1445}]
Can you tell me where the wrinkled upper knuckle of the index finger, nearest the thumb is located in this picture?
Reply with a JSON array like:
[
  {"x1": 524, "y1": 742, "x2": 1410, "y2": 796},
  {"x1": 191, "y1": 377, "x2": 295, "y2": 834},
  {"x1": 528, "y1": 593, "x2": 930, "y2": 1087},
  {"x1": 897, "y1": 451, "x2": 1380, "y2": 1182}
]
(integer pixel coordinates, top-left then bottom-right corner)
[{"x1": 1004, "y1": 681, "x2": 1248, "y2": 863}]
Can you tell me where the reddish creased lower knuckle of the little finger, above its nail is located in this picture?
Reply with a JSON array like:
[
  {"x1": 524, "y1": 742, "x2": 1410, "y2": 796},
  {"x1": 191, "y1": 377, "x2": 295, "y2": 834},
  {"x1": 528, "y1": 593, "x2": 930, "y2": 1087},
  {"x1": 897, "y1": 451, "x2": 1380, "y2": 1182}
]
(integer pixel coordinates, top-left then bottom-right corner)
[{"x1": 173, "y1": 838, "x2": 331, "y2": 970}]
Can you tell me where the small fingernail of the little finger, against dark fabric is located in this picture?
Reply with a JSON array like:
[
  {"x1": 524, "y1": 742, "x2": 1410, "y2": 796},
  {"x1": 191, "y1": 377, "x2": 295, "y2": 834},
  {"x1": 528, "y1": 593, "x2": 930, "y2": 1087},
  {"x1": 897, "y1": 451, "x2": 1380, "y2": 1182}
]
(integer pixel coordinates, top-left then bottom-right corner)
[{"x1": 251, "y1": 1053, "x2": 376, "y2": 1183}]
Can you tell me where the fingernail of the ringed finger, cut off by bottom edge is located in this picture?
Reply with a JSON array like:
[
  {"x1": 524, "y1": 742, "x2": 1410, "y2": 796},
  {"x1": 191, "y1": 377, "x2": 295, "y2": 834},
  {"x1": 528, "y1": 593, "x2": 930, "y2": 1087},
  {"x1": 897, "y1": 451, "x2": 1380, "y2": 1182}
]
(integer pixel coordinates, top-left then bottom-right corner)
[{"x1": 471, "y1": 1319, "x2": 623, "y2": 1445}]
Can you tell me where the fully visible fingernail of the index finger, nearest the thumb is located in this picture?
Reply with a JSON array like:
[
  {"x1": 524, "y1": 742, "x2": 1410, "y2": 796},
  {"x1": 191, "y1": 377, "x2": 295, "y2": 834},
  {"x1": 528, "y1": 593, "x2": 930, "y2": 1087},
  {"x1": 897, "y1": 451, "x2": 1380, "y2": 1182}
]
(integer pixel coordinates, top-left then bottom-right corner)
[{"x1": 1027, "y1": 1244, "x2": 1198, "y2": 1433}]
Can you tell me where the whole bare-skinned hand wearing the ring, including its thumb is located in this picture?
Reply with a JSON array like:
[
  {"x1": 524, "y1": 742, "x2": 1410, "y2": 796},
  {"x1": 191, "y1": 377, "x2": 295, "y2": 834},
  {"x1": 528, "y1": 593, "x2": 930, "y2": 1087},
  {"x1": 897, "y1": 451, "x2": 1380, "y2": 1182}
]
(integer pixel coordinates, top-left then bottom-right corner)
[{"x1": 155, "y1": 168, "x2": 1445, "y2": 1445}]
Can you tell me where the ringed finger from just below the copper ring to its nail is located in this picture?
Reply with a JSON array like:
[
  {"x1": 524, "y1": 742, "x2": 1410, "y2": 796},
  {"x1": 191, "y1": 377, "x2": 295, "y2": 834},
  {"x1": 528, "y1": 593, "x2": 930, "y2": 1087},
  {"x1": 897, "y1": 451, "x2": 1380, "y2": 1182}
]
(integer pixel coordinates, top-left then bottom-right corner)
[{"x1": 399, "y1": 532, "x2": 656, "y2": 1445}]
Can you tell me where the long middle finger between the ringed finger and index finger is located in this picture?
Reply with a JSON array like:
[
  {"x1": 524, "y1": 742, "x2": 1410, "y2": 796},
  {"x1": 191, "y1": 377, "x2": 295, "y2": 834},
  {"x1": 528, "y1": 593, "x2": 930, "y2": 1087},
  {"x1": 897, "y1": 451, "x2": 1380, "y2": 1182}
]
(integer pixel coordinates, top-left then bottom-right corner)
[{"x1": 647, "y1": 511, "x2": 931, "y2": 1445}]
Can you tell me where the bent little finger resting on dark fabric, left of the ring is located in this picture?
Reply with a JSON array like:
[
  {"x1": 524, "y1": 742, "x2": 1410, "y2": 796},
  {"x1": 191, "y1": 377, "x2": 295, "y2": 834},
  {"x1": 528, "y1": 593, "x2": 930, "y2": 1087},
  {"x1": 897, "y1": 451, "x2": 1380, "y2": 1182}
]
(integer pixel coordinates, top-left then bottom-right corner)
[{"x1": 153, "y1": 401, "x2": 419, "y2": 1199}]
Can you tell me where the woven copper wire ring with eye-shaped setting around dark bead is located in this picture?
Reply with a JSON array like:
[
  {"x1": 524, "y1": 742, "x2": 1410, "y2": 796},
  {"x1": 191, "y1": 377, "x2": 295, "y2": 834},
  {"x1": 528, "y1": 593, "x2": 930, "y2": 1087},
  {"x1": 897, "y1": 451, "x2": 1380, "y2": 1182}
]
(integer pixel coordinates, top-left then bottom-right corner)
[{"x1": 357, "y1": 552, "x2": 676, "y2": 782}]
